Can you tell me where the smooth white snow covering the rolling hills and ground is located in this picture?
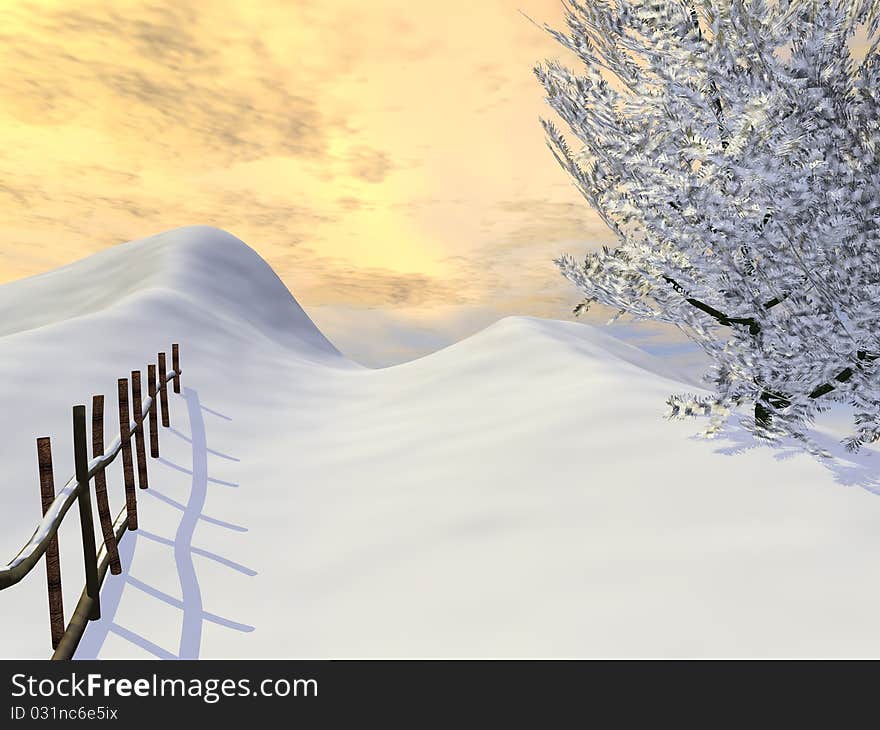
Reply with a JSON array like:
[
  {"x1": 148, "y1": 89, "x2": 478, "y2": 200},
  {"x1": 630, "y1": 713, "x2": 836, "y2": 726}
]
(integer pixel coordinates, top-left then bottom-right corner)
[{"x1": 0, "y1": 227, "x2": 880, "y2": 658}]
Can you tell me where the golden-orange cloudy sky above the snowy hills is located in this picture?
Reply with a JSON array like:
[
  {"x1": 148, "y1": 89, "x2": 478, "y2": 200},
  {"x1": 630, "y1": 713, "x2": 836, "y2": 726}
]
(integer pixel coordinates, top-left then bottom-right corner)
[{"x1": 0, "y1": 0, "x2": 668, "y2": 366}]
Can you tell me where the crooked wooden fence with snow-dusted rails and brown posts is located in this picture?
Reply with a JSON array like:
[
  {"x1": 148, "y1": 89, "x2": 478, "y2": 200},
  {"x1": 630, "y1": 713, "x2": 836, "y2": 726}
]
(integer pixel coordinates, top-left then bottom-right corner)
[{"x1": 0, "y1": 344, "x2": 182, "y2": 659}]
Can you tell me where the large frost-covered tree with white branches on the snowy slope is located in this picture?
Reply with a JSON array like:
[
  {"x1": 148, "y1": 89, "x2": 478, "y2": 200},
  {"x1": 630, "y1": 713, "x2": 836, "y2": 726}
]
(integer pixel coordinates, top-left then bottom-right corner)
[{"x1": 535, "y1": 0, "x2": 880, "y2": 453}]
